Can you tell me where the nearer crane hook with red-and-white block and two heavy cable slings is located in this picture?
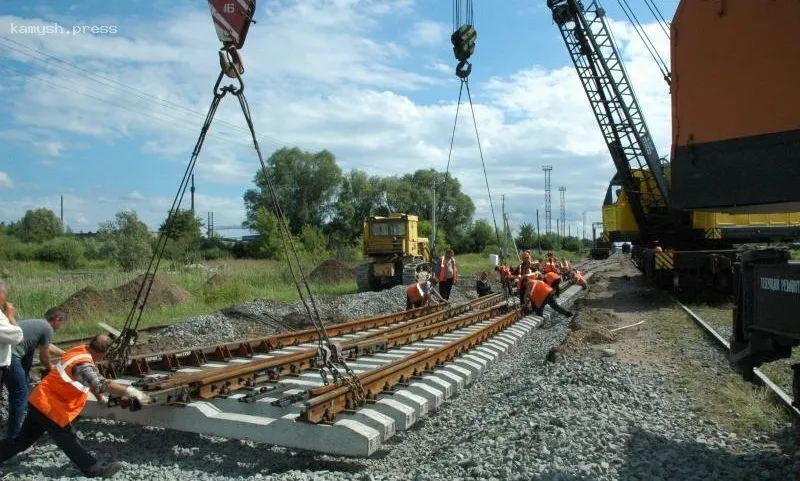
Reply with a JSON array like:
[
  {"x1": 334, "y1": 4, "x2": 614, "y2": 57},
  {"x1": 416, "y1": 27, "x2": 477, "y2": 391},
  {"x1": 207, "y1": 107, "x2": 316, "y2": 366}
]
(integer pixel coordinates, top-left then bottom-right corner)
[{"x1": 108, "y1": 0, "x2": 366, "y2": 404}]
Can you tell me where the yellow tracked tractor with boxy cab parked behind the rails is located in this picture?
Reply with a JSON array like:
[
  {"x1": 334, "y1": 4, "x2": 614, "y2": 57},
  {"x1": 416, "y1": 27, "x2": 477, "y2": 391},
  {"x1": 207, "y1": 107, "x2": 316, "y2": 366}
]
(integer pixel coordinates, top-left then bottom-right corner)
[{"x1": 356, "y1": 214, "x2": 433, "y2": 292}]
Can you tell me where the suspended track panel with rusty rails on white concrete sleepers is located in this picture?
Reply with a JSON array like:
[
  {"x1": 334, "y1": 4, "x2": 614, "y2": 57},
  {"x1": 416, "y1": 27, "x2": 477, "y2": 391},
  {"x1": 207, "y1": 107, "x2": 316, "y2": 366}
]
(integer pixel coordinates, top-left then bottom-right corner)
[{"x1": 84, "y1": 275, "x2": 589, "y2": 456}]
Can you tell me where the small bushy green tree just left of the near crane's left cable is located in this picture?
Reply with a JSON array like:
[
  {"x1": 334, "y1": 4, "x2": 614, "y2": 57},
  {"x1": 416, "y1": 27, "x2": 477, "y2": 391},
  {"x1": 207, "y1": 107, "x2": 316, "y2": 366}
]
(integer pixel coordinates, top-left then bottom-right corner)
[{"x1": 98, "y1": 211, "x2": 153, "y2": 271}]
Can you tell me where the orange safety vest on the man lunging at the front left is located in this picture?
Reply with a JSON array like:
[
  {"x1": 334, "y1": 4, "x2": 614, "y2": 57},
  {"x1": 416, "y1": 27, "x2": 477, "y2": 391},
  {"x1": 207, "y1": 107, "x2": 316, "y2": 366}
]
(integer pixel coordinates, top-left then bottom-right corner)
[{"x1": 28, "y1": 345, "x2": 94, "y2": 428}]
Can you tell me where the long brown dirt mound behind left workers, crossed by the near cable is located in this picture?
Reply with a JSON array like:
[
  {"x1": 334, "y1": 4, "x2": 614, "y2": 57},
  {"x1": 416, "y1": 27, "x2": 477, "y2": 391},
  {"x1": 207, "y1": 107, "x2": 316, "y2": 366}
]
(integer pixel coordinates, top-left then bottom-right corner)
[{"x1": 58, "y1": 274, "x2": 192, "y2": 316}]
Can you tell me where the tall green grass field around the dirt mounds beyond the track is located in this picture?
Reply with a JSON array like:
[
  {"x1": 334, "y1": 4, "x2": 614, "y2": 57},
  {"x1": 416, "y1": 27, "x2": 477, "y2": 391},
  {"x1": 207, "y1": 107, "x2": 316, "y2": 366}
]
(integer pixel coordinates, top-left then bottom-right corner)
[{"x1": 0, "y1": 249, "x2": 575, "y2": 341}]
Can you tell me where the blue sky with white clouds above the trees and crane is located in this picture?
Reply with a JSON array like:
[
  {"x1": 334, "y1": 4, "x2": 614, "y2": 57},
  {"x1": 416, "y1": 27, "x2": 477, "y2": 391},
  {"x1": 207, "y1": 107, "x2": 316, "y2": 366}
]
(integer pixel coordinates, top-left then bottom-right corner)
[{"x1": 0, "y1": 0, "x2": 678, "y2": 240}]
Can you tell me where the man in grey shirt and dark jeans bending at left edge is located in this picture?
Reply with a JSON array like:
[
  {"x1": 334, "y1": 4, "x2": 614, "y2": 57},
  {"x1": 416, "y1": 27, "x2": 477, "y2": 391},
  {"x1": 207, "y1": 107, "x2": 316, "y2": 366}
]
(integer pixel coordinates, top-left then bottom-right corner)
[{"x1": 3, "y1": 308, "x2": 66, "y2": 438}]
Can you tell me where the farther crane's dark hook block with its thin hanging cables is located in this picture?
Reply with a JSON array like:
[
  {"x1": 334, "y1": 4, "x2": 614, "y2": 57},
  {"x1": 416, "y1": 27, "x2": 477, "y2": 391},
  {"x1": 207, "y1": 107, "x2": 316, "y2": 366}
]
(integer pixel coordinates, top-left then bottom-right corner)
[{"x1": 434, "y1": 0, "x2": 500, "y2": 258}]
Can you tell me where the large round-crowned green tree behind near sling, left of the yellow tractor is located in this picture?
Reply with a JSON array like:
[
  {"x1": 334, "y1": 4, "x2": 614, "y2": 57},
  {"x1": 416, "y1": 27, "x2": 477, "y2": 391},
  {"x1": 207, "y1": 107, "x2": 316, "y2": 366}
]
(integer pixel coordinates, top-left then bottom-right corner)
[{"x1": 244, "y1": 148, "x2": 342, "y2": 234}]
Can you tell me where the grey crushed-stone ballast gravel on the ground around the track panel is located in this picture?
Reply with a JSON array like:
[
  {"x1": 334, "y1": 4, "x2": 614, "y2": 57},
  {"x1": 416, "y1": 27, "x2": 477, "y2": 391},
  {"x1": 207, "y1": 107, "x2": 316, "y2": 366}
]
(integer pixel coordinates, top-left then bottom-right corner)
[{"x1": 0, "y1": 264, "x2": 800, "y2": 481}]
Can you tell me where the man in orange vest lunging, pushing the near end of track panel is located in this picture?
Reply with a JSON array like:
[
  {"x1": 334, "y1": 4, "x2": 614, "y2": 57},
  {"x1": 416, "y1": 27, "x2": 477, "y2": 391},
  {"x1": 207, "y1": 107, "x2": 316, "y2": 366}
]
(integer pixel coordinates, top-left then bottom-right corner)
[{"x1": 0, "y1": 334, "x2": 151, "y2": 478}]
